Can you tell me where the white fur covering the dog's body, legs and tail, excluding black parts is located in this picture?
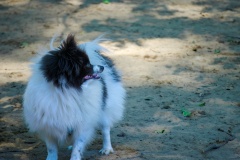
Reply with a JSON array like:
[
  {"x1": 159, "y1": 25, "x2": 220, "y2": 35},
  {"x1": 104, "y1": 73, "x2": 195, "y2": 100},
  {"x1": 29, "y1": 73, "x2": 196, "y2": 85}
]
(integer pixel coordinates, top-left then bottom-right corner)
[{"x1": 23, "y1": 36, "x2": 125, "y2": 160}]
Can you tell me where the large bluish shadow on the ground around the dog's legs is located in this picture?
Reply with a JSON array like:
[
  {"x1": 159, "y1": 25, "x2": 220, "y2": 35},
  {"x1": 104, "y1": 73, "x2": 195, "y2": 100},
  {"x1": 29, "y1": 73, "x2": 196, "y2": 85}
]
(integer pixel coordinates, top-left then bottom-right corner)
[{"x1": 0, "y1": 82, "x2": 240, "y2": 159}]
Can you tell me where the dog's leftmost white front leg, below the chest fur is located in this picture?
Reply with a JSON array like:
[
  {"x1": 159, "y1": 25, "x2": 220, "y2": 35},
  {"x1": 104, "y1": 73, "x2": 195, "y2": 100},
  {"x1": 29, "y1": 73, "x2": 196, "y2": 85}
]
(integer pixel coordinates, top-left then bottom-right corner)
[{"x1": 45, "y1": 140, "x2": 58, "y2": 160}]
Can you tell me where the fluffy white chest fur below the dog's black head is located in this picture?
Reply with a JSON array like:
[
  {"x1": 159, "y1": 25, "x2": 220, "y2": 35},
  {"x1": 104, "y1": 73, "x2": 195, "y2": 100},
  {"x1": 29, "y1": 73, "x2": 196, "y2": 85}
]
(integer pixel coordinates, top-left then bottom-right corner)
[{"x1": 25, "y1": 76, "x2": 103, "y2": 141}]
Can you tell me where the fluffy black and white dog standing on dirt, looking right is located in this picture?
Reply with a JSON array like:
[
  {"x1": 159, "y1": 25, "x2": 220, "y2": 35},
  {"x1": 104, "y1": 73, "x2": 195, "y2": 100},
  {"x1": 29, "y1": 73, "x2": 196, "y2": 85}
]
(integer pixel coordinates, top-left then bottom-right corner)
[{"x1": 23, "y1": 34, "x2": 125, "y2": 160}]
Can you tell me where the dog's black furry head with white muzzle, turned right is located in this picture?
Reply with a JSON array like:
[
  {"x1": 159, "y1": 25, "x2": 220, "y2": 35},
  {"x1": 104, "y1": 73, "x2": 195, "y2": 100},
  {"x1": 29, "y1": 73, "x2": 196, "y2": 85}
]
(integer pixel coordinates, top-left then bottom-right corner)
[{"x1": 40, "y1": 34, "x2": 104, "y2": 88}]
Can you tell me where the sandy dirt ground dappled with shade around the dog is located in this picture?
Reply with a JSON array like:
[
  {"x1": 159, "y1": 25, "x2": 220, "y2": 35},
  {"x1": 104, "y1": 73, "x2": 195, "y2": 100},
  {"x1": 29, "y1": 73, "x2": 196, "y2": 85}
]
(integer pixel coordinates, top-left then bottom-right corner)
[{"x1": 0, "y1": 0, "x2": 240, "y2": 160}]
